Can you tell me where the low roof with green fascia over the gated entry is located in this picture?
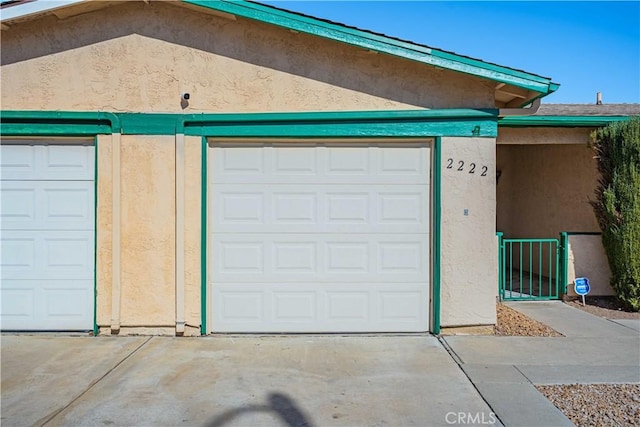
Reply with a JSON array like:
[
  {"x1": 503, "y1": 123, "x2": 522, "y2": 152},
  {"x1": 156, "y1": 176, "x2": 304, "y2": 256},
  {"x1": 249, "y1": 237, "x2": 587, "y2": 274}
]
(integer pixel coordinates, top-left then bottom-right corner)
[{"x1": 498, "y1": 104, "x2": 640, "y2": 127}]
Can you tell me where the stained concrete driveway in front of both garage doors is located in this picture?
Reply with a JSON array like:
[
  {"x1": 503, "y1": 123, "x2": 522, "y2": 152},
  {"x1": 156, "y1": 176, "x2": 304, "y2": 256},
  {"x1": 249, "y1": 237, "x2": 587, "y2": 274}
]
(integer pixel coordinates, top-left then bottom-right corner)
[{"x1": 2, "y1": 335, "x2": 494, "y2": 427}]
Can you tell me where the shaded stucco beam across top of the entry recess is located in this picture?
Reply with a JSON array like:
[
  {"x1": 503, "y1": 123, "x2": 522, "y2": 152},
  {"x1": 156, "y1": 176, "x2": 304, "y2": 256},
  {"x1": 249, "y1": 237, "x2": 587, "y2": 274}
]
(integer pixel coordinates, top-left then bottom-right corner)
[{"x1": 497, "y1": 127, "x2": 594, "y2": 145}]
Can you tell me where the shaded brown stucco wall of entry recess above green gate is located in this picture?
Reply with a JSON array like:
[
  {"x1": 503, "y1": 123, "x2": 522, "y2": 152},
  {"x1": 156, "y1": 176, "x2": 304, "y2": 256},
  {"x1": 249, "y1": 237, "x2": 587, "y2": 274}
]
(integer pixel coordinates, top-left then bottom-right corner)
[{"x1": 497, "y1": 145, "x2": 599, "y2": 238}]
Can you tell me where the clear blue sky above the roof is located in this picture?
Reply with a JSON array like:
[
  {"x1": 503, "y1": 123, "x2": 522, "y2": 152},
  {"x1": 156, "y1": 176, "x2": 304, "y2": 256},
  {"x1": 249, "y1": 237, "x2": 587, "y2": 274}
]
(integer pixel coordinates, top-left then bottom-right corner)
[{"x1": 259, "y1": 0, "x2": 640, "y2": 103}]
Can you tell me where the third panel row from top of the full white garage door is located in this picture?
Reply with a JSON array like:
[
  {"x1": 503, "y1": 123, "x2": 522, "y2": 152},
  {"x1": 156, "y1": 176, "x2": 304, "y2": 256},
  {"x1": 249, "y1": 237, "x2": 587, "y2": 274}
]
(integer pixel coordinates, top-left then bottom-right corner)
[{"x1": 212, "y1": 233, "x2": 429, "y2": 282}]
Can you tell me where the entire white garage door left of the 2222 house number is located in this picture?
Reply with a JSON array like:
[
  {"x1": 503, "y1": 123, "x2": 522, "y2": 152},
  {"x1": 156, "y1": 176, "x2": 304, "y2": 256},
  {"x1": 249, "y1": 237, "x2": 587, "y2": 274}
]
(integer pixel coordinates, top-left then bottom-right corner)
[{"x1": 209, "y1": 144, "x2": 430, "y2": 332}]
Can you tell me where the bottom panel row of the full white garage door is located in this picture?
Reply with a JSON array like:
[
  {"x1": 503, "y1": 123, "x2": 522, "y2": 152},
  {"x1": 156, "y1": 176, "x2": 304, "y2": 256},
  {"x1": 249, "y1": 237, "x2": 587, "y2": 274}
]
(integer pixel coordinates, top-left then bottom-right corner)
[{"x1": 213, "y1": 282, "x2": 429, "y2": 332}]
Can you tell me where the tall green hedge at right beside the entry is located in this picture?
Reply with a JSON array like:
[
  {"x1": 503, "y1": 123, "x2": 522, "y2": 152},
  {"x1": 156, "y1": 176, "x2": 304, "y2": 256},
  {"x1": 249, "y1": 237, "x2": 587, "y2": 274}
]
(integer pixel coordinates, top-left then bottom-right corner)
[{"x1": 591, "y1": 117, "x2": 640, "y2": 311}]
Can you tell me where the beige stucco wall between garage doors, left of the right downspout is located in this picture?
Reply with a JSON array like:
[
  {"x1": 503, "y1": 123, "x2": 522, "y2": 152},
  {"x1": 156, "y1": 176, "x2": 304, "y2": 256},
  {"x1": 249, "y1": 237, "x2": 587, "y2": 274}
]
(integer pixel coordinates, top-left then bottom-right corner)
[{"x1": 96, "y1": 135, "x2": 178, "y2": 332}]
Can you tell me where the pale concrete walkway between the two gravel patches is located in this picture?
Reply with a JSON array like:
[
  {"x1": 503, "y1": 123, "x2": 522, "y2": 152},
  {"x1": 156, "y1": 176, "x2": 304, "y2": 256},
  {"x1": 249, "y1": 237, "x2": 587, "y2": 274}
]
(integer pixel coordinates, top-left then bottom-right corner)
[{"x1": 443, "y1": 301, "x2": 640, "y2": 427}]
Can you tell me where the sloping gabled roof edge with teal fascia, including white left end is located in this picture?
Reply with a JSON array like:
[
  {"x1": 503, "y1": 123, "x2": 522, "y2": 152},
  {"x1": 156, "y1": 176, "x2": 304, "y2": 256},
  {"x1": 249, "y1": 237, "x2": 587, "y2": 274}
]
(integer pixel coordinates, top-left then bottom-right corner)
[{"x1": 1, "y1": 0, "x2": 559, "y2": 107}]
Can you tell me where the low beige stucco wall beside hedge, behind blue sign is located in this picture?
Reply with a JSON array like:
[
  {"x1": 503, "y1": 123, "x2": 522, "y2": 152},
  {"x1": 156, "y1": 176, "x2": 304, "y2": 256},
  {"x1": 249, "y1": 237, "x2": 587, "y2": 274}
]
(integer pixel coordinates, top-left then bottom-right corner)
[{"x1": 567, "y1": 235, "x2": 615, "y2": 296}]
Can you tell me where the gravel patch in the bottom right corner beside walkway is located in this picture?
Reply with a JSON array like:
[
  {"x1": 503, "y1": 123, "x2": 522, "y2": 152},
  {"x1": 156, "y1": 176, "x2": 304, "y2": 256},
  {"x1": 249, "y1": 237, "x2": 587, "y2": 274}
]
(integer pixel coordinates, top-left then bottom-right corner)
[{"x1": 536, "y1": 384, "x2": 640, "y2": 427}]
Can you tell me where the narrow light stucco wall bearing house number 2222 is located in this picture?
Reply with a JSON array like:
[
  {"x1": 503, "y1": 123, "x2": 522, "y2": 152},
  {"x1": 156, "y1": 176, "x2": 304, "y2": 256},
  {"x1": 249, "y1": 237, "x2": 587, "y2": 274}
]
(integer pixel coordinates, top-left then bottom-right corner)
[{"x1": 441, "y1": 138, "x2": 498, "y2": 327}]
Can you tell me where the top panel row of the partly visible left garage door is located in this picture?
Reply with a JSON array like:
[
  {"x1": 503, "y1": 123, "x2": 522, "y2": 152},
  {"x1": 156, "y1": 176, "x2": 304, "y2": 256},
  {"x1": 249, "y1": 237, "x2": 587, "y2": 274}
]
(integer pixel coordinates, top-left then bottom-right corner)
[{"x1": 0, "y1": 145, "x2": 95, "y2": 181}]
